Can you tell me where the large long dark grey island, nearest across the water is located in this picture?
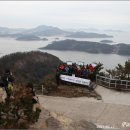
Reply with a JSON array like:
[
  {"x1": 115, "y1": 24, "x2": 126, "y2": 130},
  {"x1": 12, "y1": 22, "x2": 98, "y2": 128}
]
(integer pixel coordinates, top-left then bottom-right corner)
[{"x1": 40, "y1": 39, "x2": 130, "y2": 55}]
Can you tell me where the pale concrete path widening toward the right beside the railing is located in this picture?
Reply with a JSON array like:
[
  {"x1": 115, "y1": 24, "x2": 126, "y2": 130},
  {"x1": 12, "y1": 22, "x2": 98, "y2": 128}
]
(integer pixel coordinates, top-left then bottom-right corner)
[{"x1": 39, "y1": 86, "x2": 130, "y2": 129}]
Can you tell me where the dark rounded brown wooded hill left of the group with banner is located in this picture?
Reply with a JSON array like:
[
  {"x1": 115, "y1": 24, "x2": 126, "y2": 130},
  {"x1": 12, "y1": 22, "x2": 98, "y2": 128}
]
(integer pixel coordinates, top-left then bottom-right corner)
[{"x1": 0, "y1": 51, "x2": 61, "y2": 85}]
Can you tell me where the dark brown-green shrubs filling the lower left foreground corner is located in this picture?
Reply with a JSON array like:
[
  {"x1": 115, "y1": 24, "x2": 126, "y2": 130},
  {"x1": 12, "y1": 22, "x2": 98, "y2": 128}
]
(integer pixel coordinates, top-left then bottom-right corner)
[{"x1": 0, "y1": 88, "x2": 40, "y2": 129}]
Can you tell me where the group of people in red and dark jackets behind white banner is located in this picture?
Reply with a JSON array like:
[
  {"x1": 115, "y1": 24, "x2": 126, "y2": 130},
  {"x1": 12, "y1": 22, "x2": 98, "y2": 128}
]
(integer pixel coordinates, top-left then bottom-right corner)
[{"x1": 57, "y1": 63, "x2": 96, "y2": 79}]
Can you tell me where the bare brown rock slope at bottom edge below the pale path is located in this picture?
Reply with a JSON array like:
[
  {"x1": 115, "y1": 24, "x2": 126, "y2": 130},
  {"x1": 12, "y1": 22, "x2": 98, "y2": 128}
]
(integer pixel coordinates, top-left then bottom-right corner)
[{"x1": 30, "y1": 109, "x2": 101, "y2": 130}]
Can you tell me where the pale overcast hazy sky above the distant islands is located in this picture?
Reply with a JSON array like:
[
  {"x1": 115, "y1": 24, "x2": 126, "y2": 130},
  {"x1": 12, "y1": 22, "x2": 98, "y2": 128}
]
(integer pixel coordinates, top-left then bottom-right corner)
[{"x1": 0, "y1": 1, "x2": 130, "y2": 29}]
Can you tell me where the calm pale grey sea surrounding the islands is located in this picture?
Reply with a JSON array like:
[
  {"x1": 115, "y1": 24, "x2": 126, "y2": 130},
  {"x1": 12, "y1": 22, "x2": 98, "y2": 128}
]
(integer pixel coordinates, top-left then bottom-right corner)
[{"x1": 0, "y1": 32, "x2": 130, "y2": 70}]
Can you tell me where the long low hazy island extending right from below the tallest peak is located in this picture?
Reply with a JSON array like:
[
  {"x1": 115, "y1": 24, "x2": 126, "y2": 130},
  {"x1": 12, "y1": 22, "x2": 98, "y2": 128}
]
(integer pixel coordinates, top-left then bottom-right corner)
[{"x1": 66, "y1": 32, "x2": 113, "y2": 38}]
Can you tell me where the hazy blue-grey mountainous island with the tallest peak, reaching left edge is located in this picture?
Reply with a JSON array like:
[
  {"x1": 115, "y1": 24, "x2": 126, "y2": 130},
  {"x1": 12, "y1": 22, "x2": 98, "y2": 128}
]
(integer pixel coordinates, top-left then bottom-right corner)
[{"x1": 0, "y1": 25, "x2": 67, "y2": 38}]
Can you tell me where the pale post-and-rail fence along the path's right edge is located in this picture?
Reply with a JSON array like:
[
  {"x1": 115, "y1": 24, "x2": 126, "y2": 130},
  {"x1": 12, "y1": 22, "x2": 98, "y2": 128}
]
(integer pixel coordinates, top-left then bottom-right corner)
[{"x1": 96, "y1": 75, "x2": 130, "y2": 90}]
